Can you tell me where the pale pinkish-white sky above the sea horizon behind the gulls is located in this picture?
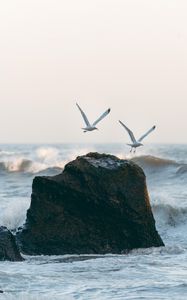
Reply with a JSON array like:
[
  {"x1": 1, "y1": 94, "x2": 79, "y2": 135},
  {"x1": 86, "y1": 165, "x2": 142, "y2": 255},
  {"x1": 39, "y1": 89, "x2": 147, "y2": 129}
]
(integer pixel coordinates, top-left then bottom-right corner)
[{"x1": 0, "y1": 0, "x2": 187, "y2": 143}]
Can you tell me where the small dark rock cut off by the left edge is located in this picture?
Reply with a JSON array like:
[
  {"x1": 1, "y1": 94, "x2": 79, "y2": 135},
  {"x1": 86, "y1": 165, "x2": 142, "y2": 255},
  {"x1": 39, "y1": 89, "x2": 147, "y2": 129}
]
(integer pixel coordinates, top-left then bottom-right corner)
[{"x1": 0, "y1": 226, "x2": 24, "y2": 261}]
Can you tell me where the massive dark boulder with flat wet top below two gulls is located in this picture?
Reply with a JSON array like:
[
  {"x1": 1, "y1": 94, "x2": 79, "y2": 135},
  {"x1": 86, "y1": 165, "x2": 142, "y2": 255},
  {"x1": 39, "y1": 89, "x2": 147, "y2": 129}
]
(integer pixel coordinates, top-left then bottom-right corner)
[{"x1": 18, "y1": 153, "x2": 164, "y2": 254}]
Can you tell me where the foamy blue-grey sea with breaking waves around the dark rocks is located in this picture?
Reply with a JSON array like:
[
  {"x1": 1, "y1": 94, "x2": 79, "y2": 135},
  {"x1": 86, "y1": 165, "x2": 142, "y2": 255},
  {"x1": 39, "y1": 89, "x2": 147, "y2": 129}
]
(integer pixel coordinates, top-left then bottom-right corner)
[{"x1": 0, "y1": 144, "x2": 187, "y2": 300}]
